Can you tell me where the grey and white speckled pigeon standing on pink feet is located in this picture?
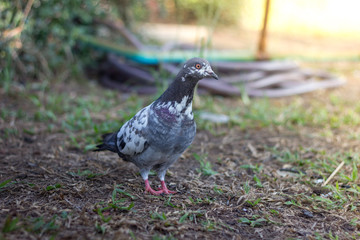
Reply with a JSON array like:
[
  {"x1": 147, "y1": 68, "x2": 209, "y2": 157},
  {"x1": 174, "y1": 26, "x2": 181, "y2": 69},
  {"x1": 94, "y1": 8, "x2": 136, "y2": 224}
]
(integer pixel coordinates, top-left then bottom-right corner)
[{"x1": 94, "y1": 58, "x2": 218, "y2": 195}]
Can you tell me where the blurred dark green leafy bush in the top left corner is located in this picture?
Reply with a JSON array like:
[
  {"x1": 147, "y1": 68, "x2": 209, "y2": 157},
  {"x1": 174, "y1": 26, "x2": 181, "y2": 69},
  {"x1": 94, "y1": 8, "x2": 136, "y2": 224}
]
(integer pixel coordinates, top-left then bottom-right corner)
[{"x1": 0, "y1": 0, "x2": 105, "y2": 85}]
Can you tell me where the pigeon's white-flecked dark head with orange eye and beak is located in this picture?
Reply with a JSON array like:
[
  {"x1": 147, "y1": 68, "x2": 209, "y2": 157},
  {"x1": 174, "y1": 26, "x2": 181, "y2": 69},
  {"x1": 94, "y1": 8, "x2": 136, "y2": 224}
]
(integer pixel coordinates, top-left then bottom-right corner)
[{"x1": 181, "y1": 58, "x2": 218, "y2": 81}]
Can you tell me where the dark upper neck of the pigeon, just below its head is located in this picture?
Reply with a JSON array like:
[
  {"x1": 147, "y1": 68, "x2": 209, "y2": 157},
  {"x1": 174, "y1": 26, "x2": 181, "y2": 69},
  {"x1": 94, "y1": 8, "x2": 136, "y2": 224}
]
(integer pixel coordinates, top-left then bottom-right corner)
[{"x1": 158, "y1": 73, "x2": 198, "y2": 105}]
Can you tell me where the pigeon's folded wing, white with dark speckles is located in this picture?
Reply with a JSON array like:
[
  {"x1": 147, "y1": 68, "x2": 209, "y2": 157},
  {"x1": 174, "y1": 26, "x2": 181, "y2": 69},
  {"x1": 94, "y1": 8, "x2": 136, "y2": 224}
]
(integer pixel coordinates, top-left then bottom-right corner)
[{"x1": 117, "y1": 106, "x2": 150, "y2": 157}]
